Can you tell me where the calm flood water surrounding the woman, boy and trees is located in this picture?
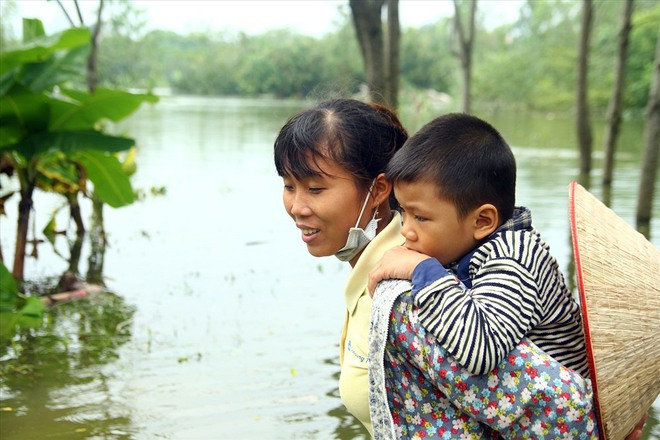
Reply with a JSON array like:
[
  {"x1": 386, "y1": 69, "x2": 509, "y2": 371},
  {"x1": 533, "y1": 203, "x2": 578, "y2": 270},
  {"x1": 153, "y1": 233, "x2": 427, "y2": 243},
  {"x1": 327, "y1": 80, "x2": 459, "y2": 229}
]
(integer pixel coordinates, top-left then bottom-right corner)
[{"x1": 0, "y1": 97, "x2": 660, "y2": 440}]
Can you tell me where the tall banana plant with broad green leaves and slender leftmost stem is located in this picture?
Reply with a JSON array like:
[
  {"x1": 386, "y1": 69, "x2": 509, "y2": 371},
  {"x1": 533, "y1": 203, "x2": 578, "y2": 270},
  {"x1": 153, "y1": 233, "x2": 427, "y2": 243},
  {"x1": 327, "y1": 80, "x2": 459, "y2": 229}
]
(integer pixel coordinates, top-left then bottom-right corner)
[{"x1": 0, "y1": 19, "x2": 157, "y2": 281}]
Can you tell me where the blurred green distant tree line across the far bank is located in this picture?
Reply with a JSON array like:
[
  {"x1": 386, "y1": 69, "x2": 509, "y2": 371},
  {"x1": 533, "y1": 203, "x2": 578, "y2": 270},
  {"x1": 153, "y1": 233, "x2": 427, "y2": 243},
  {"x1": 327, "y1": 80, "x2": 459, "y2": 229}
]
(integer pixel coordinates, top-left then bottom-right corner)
[{"x1": 85, "y1": 0, "x2": 660, "y2": 112}]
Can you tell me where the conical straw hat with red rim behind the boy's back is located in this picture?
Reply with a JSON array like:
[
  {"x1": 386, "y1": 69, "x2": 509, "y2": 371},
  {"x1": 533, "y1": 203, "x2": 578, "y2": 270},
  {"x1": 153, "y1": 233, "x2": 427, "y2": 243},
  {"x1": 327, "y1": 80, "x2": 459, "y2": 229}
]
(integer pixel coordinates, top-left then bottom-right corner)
[{"x1": 569, "y1": 182, "x2": 660, "y2": 440}]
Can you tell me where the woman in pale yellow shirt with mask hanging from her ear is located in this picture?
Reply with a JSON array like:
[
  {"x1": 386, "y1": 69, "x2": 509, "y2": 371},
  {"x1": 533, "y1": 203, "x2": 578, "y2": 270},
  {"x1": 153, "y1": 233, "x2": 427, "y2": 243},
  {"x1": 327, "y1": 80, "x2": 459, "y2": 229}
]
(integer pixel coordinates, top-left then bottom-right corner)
[{"x1": 274, "y1": 99, "x2": 644, "y2": 440}]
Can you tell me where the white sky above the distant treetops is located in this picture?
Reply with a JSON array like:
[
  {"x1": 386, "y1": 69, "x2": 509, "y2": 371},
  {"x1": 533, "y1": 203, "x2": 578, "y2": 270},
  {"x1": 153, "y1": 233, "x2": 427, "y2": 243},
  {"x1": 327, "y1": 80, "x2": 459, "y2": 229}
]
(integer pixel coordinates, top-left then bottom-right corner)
[{"x1": 0, "y1": 0, "x2": 522, "y2": 36}]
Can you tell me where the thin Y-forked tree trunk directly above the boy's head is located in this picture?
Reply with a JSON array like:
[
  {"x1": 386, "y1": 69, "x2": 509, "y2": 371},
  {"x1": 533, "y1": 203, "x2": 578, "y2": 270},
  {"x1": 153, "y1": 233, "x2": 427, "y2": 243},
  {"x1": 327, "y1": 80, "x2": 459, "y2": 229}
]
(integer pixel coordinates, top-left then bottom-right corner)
[{"x1": 454, "y1": 0, "x2": 477, "y2": 113}]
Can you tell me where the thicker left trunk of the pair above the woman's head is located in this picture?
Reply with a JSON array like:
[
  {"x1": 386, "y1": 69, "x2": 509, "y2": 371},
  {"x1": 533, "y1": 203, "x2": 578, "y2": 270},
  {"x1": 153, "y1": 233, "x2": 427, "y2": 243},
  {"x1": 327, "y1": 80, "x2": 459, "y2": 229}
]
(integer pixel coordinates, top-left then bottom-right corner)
[{"x1": 349, "y1": 0, "x2": 385, "y2": 103}]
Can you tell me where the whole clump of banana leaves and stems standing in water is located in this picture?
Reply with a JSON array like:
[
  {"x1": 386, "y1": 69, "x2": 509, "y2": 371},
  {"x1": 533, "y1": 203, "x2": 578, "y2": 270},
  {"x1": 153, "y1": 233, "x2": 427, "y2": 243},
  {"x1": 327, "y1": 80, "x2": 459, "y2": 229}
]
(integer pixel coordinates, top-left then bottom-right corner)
[{"x1": 0, "y1": 19, "x2": 157, "y2": 337}]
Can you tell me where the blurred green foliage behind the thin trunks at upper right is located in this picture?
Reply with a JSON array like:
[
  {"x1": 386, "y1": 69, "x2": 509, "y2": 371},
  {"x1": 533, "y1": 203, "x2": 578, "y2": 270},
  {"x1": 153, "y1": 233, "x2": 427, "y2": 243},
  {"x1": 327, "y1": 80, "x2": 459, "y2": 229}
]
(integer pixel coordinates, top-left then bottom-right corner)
[{"x1": 474, "y1": 0, "x2": 660, "y2": 114}]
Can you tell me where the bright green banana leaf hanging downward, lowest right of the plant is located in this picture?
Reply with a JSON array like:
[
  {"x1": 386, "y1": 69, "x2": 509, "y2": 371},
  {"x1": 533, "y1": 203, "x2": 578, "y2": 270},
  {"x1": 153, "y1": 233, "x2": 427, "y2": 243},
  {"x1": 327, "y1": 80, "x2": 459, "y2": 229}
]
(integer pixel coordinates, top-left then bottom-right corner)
[{"x1": 72, "y1": 151, "x2": 135, "y2": 208}]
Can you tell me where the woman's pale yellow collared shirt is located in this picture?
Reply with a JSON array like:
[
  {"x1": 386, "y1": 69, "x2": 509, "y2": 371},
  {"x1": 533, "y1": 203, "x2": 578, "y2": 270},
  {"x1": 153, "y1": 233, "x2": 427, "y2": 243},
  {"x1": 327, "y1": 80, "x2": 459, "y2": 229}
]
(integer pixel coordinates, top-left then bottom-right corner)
[{"x1": 339, "y1": 212, "x2": 405, "y2": 435}]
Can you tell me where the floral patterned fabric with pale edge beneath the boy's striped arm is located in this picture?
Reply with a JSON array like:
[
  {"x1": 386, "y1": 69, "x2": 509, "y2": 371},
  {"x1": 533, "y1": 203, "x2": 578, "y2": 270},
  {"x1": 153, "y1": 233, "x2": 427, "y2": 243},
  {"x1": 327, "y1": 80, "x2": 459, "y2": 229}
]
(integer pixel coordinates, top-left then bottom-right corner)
[{"x1": 369, "y1": 280, "x2": 598, "y2": 439}]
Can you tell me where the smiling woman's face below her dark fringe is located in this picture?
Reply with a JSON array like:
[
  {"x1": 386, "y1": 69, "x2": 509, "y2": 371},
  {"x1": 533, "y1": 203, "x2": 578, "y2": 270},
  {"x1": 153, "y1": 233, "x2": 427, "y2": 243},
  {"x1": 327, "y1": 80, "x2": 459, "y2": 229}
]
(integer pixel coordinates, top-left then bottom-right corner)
[{"x1": 283, "y1": 158, "x2": 373, "y2": 257}]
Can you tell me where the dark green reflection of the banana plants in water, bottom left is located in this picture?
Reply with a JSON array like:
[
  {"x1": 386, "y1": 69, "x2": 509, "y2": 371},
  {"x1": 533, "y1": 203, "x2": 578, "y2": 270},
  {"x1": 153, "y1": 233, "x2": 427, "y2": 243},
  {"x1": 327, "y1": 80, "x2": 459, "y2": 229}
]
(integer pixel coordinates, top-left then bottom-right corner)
[{"x1": 0, "y1": 292, "x2": 135, "y2": 440}]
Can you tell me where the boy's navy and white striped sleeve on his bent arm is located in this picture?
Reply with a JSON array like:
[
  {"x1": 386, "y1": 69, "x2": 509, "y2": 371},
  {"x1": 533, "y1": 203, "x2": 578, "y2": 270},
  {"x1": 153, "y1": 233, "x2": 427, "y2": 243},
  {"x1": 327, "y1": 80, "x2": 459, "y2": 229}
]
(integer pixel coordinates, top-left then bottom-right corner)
[{"x1": 413, "y1": 237, "x2": 543, "y2": 374}]
